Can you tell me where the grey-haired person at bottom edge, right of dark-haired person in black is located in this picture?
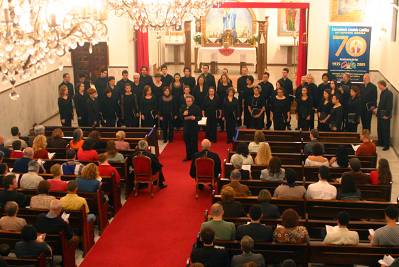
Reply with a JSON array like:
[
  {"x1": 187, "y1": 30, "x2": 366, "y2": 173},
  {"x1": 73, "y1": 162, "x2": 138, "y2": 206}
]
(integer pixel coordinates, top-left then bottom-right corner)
[{"x1": 231, "y1": 237, "x2": 271, "y2": 267}]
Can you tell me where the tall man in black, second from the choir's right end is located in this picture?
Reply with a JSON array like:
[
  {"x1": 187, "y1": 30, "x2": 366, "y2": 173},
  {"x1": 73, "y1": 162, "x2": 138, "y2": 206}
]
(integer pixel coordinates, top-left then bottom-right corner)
[{"x1": 360, "y1": 73, "x2": 377, "y2": 131}]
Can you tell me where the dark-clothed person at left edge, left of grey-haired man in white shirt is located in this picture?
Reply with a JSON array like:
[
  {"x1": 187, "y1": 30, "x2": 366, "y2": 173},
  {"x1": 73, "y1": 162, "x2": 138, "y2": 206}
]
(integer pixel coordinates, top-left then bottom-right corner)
[{"x1": 0, "y1": 173, "x2": 26, "y2": 208}]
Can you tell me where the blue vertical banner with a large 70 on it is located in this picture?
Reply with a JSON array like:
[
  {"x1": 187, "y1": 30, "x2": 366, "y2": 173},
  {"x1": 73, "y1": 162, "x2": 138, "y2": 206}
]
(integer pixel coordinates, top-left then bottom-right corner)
[{"x1": 328, "y1": 26, "x2": 371, "y2": 82}]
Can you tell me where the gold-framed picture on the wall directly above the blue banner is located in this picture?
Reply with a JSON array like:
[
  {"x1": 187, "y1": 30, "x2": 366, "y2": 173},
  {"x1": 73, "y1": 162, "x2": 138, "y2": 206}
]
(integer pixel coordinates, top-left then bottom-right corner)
[{"x1": 330, "y1": 0, "x2": 368, "y2": 22}]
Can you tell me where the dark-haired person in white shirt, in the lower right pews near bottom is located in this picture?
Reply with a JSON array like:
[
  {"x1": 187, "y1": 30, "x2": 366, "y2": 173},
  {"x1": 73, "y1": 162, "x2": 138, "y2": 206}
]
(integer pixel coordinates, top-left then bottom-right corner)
[{"x1": 323, "y1": 211, "x2": 359, "y2": 245}]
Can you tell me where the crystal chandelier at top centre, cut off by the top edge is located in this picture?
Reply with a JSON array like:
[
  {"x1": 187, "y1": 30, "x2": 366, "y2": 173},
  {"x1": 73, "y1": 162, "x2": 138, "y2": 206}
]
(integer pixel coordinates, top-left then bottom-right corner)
[{"x1": 109, "y1": 0, "x2": 224, "y2": 31}]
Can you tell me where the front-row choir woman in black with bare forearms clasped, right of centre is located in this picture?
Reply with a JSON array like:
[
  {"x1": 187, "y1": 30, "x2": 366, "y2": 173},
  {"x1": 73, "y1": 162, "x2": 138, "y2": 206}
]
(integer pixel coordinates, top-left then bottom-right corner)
[{"x1": 248, "y1": 86, "x2": 266, "y2": 130}]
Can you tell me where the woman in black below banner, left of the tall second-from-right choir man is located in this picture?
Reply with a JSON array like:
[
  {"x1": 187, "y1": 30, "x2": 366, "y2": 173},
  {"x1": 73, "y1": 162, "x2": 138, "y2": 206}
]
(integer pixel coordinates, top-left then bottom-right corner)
[{"x1": 345, "y1": 86, "x2": 362, "y2": 133}]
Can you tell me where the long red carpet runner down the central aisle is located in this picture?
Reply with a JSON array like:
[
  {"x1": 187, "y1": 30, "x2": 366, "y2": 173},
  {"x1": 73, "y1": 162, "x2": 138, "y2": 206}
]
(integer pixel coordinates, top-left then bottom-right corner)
[{"x1": 80, "y1": 133, "x2": 228, "y2": 267}]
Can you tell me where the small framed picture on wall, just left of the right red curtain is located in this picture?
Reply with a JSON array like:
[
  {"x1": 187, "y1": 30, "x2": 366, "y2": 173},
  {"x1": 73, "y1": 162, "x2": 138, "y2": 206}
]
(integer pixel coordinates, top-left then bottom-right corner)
[{"x1": 277, "y1": 8, "x2": 299, "y2": 36}]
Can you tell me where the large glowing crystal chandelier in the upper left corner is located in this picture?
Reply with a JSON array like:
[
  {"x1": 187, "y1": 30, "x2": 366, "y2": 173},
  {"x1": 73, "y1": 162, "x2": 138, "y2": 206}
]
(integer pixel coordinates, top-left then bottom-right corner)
[{"x1": 0, "y1": 0, "x2": 107, "y2": 99}]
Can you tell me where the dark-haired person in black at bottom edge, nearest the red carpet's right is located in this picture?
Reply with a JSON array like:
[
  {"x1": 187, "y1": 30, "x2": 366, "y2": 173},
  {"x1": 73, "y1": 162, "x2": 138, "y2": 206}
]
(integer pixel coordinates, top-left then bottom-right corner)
[{"x1": 190, "y1": 227, "x2": 230, "y2": 267}]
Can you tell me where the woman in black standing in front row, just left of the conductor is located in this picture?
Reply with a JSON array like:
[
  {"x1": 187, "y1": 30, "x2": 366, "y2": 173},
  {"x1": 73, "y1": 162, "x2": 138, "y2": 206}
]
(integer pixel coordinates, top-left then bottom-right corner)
[{"x1": 158, "y1": 87, "x2": 179, "y2": 143}]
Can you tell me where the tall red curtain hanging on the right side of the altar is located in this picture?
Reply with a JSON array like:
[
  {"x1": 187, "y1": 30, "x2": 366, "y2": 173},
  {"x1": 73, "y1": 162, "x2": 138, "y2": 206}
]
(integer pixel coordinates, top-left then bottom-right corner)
[{"x1": 296, "y1": 9, "x2": 308, "y2": 86}]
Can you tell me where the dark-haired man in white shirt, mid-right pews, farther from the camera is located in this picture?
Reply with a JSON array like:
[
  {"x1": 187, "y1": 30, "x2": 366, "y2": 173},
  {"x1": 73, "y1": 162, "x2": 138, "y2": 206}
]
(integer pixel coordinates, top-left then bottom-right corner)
[{"x1": 306, "y1": 166, "x2": 337, "y2": 200}]
